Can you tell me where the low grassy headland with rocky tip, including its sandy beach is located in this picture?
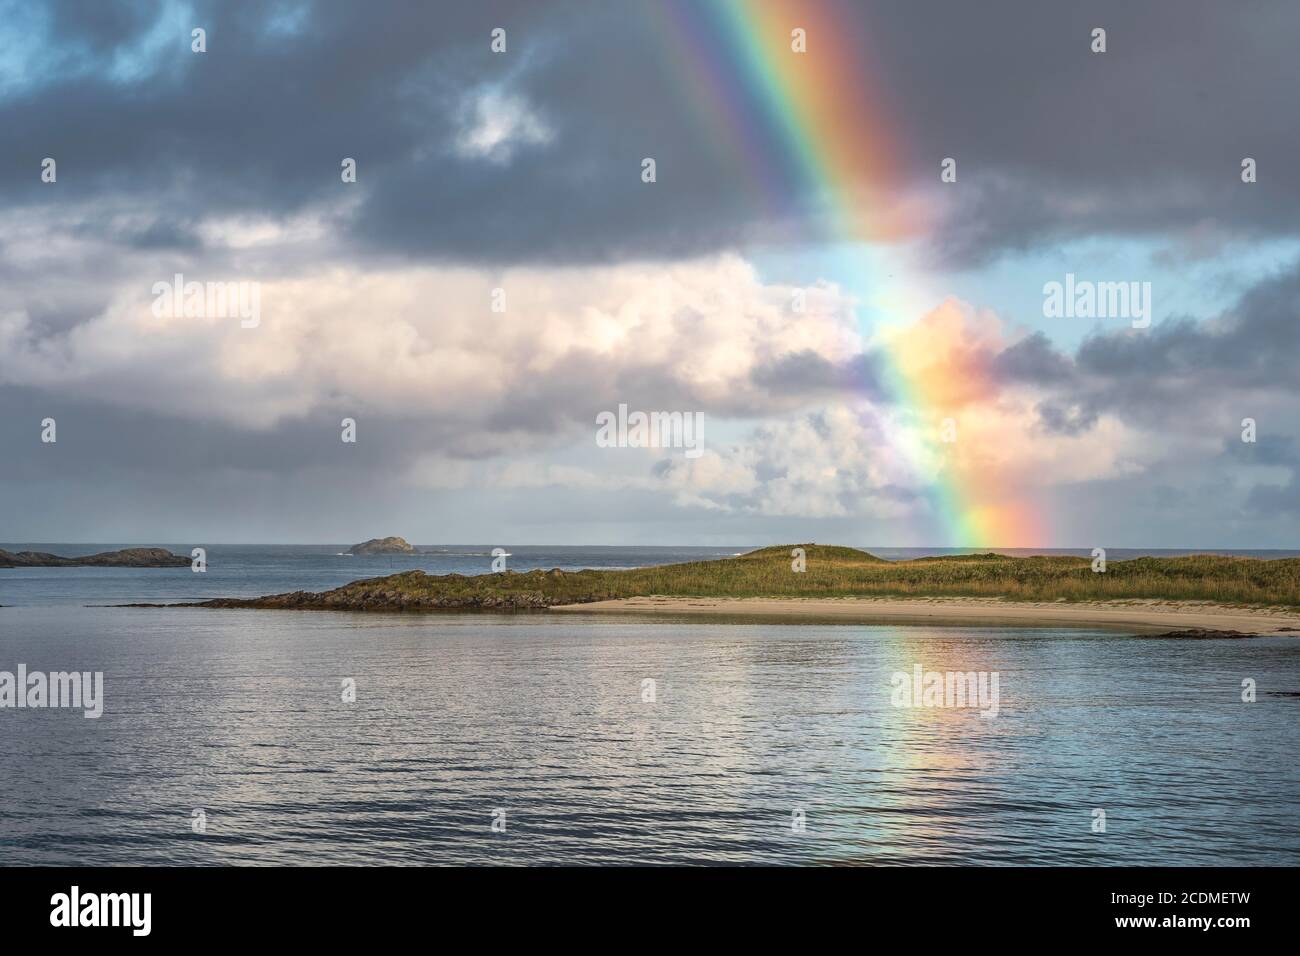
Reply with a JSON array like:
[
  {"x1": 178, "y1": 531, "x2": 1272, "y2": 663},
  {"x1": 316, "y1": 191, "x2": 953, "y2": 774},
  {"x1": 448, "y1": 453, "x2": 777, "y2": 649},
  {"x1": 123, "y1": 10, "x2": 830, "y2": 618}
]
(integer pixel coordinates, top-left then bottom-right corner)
[{"x1": 81, "y1": 544, "x2": 1300, "y2": 621}]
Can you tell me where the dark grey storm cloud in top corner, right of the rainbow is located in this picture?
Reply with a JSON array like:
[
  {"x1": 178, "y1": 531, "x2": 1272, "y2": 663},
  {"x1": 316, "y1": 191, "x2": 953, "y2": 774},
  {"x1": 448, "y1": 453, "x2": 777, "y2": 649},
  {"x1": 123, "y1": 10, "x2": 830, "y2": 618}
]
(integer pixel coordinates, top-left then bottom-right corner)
[{"x1": 879, "y1": 0, "x2": 1300, "y2": 264}]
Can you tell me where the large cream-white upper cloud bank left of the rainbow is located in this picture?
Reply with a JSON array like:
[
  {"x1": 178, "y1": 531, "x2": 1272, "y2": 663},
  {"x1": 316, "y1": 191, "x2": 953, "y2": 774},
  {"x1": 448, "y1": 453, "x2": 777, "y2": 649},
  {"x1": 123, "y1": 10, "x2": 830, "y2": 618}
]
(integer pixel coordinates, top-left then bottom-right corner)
[{"x1": 0, "y1": 243, "x2": 858, "y2": 444}]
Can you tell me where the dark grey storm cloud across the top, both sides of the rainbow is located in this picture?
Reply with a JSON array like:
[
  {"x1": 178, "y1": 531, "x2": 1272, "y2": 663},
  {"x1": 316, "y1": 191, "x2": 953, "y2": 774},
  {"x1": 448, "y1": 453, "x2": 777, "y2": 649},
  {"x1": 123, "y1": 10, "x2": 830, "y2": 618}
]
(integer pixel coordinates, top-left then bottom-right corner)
[{"x1": 0, "y1": 0, "x2": 1300, "y2": 264}]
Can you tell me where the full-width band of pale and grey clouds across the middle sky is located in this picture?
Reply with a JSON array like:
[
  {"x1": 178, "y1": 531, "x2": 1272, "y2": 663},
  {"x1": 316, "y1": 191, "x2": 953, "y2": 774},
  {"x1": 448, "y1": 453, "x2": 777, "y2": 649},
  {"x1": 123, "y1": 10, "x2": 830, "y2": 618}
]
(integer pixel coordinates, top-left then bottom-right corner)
[{"x1": 0, "y1": 212, "x2": 1300, "y2": 538}]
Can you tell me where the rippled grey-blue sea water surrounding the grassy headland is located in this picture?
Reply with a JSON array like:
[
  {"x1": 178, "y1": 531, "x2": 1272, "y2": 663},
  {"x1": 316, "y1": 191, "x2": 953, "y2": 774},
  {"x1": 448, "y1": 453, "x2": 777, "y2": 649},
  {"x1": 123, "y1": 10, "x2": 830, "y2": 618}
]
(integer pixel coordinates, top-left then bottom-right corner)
[{"x1": 0, "y1": 546, "x2": 1300, "y2": 865}]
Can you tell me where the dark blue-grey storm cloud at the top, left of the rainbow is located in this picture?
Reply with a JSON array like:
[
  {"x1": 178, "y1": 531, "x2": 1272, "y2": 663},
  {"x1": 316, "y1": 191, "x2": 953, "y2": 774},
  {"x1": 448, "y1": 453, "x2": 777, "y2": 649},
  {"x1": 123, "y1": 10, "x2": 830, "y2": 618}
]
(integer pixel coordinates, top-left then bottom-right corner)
[{"x1": 0, "y1": 3, "x2": 800, "y2": 261}]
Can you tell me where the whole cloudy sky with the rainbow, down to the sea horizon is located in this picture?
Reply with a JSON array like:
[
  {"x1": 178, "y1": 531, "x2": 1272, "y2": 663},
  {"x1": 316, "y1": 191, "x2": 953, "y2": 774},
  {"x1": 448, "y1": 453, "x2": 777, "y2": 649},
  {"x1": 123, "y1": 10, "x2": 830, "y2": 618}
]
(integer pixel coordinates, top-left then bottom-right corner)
[{"x1": 0, "y1": 0, "x2": 1300, "y2": 548}]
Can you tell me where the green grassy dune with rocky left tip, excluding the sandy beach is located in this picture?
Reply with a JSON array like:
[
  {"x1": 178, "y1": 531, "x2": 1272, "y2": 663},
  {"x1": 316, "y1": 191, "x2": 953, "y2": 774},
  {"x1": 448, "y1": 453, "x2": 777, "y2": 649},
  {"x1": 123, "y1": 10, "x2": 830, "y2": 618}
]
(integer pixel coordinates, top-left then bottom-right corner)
[{"x1": 203, "y1": 545, "x2": 1300, "y2": 610}]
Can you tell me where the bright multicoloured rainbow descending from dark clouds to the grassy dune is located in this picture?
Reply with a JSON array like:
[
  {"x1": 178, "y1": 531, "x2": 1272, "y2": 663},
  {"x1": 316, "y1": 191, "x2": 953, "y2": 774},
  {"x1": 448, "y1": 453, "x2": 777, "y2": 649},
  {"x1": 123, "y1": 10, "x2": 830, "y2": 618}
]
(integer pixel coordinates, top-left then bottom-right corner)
[{"x1": 647, "y1": 0, "x2": 1045, "y2": 548}]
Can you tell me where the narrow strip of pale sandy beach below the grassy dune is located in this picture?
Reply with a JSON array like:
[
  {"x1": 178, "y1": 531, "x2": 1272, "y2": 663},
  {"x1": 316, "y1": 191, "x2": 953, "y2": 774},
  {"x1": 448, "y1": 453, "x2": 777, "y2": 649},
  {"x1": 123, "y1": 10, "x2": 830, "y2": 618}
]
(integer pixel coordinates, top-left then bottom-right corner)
[{"x1": 551, "y1": 597, "x2": 1300, "y2": 636}]
